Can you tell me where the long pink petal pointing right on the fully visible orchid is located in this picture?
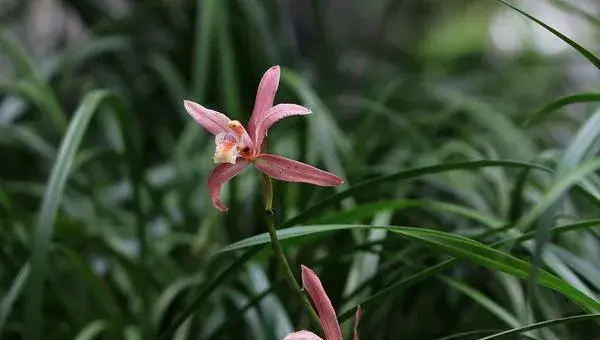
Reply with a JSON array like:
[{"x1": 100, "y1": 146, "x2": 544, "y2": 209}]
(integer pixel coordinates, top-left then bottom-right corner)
[{"x1": 254, "y1": 154, "x2": 344, "y2": 187}]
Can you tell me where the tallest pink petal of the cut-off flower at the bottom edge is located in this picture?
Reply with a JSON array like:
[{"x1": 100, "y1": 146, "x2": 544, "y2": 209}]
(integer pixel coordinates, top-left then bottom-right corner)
[{"x1": 302, "y1": 265, "x2": 343, "y2": 340}]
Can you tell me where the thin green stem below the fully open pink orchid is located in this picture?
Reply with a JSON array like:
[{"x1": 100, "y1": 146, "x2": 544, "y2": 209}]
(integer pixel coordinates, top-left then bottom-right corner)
[{"x1": 262, "y1": 174, "x2": 321, "y2": 328}]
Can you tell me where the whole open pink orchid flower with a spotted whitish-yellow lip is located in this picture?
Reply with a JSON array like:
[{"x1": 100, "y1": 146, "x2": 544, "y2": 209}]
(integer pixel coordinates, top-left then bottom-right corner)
[{"x1": 184, "y1": 66, "x2": 344, "y2": 211}]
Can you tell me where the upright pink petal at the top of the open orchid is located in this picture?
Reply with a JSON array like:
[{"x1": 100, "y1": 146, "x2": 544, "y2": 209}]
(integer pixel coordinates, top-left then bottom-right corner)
[{"x1": 248, "y1": 66, "x2": 281, "y2": 141}]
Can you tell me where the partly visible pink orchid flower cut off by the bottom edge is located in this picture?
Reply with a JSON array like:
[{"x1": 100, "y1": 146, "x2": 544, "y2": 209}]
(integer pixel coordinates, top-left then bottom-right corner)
[{"x1": 283, "y1": 266, "x2": 362, "y2": 340}]
